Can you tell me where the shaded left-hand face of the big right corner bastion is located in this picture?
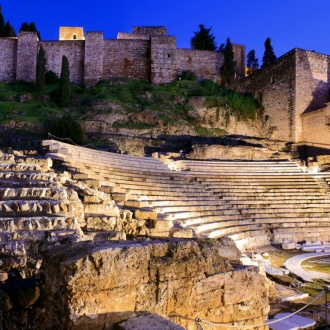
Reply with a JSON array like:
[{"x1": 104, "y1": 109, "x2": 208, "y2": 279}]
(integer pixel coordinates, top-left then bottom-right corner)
[{"x1": 237, "y1": 50, "x2": 296, "y2": 141}]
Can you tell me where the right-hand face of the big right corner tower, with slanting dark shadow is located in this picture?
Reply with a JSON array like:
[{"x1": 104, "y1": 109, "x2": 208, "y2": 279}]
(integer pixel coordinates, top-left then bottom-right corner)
[{"x1": 294, "y1": 49, "x2": 330, "y2": 141}]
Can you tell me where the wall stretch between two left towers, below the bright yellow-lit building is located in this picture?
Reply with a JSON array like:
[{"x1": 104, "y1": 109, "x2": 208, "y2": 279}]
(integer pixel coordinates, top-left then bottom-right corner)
[{"x1": 41, "y1": 41, "x2": 85, "y2": 84}]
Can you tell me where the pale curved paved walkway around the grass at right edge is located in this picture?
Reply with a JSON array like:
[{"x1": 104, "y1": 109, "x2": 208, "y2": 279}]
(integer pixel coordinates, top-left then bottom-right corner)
[{"x1": 284, "y1": 252, "x2": 330, "y2": 282}]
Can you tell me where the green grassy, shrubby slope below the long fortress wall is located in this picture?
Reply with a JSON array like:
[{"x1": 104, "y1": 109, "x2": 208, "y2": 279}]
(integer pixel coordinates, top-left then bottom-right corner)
[{"x1": 0, "y1": 79, "x2": 261, "y2": 147}]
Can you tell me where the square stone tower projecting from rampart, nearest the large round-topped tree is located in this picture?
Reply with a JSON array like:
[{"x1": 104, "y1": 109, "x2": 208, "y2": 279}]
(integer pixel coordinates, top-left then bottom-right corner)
[{"x1": 151, "y1": 36, "x2": 177, "y2": 84}]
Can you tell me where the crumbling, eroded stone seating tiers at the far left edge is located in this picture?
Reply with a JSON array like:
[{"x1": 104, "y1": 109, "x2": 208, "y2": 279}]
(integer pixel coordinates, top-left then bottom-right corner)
[{"x1": 0, "y1": 153, "x2": 80, "y2": 255}]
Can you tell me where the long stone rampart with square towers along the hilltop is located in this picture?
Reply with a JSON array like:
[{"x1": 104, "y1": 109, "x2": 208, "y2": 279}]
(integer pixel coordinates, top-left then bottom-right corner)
[{"x1": 0, "y1": 26, "x2": 245, "y2": 86}]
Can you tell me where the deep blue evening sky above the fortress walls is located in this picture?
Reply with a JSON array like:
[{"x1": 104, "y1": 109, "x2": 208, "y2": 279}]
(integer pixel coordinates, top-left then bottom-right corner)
[{"x1": 0, "y1": 0, "x2": 330, "y2": 64}]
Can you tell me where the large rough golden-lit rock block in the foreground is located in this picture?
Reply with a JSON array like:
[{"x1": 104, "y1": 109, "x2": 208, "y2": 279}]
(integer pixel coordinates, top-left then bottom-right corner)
[{"x1": 45, "y1": 239, "x2": 269, "y2": 330}]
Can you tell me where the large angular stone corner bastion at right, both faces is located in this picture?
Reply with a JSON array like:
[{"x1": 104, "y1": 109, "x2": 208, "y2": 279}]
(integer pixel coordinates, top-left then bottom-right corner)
[{"x1": 238, "y1": 49, "x2": 330, "y2": 142}]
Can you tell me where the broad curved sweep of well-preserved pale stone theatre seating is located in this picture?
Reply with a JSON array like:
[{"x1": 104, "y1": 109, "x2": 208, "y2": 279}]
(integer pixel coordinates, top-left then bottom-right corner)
[{"x1": 43, "y1": 140, "x2": 330, "y2": 251}]
